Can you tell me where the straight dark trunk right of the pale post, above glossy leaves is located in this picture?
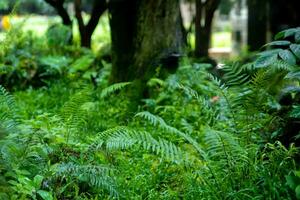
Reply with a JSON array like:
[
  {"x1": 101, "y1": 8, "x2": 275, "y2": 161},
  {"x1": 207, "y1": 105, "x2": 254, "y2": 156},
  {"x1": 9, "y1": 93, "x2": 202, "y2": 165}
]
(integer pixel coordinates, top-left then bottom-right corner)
[{"x1": 248, "y1": 0, "x2": 268, "y2": 51}]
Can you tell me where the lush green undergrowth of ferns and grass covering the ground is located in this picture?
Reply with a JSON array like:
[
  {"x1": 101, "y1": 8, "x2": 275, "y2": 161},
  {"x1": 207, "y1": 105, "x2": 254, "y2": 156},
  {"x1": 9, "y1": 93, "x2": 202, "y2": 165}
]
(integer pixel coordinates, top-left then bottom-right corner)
[{"x1": 0, "y1": 29, "x2": 300, "y2": 199}]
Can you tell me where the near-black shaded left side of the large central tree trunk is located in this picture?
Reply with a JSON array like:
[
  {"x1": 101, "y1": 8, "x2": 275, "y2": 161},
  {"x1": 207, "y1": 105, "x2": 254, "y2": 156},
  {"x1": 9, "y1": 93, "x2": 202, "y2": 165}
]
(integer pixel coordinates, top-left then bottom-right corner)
[{"x1": 109, "y1": 0, "x2": 137, "y2": 82}]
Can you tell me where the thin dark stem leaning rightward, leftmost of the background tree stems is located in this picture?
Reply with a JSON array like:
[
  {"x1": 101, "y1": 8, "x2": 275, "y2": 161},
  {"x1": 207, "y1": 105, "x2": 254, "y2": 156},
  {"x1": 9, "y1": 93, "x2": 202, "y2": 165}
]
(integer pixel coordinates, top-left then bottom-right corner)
[{"x1": 45, "y1": 0, "x2": 72, "y2": 26}]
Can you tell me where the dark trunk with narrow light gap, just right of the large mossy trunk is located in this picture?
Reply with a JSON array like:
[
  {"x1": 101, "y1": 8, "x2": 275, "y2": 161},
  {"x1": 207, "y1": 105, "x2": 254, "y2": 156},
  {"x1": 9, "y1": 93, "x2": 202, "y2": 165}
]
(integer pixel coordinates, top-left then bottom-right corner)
[{"x1": 195, "y1": 0, "x2": 221, "y2": 58}]
